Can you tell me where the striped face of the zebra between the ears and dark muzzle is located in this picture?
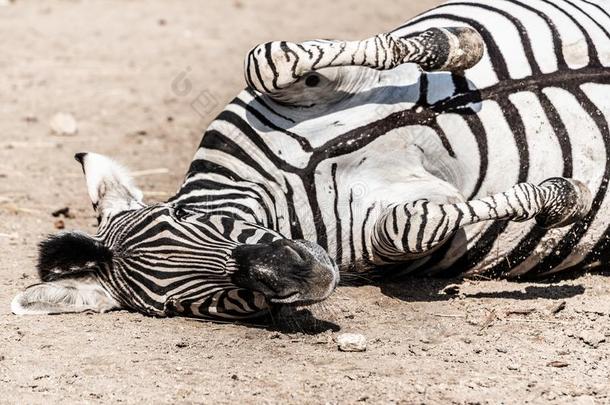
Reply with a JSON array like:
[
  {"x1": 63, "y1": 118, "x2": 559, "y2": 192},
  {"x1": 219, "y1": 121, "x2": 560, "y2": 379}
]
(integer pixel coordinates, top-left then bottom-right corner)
[{"x1": 97, "y1": 207, "x2": 278, "y2": 319}]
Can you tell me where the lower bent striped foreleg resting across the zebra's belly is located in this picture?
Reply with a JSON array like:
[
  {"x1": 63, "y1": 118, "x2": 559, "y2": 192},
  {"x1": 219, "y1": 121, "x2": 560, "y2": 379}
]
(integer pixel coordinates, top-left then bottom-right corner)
[{"x1": 372, "y1": 177, "x2": 591, "y2": 264}]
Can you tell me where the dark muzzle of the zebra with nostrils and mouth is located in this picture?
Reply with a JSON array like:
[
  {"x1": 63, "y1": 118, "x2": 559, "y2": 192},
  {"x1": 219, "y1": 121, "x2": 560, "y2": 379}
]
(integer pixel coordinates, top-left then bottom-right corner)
[{"x1": 232, "y1": 239, "x2": 339, "y2": 306}]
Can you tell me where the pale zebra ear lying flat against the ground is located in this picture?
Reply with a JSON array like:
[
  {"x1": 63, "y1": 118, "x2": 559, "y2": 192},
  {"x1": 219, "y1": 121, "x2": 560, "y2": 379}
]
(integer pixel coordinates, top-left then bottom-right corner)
[{"x1": 11, "y1": 276, "x2": 121, "y2": 315}]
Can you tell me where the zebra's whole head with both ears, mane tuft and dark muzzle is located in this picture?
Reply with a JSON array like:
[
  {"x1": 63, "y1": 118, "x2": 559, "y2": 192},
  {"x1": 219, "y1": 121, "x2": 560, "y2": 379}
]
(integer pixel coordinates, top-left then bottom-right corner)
[{"x1": 12, "y1": 153, "x2": 339, "y2": 319}]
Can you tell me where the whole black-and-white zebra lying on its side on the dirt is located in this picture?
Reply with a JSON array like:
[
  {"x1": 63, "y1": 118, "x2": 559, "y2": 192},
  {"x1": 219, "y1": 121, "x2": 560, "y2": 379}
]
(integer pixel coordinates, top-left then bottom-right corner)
[{"x1": 12, "y1": 0, "x2": 610, "y2": 319}]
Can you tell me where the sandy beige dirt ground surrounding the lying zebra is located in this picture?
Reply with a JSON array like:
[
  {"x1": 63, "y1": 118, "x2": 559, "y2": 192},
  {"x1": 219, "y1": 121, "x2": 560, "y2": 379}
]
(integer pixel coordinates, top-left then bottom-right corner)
[{"x1": 0, "y1": 0, "x2": 610, "y2": 404}]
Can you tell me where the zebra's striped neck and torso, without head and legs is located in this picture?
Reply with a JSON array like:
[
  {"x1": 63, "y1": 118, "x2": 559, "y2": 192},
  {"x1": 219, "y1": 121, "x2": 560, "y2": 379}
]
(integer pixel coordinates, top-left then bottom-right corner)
[{"x1": 174, "y1": 0, "x2": 610, "y2": 275}]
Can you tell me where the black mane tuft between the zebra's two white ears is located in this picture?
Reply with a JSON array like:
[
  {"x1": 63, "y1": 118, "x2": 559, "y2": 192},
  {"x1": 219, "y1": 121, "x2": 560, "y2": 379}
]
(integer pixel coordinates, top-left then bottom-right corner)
[{"x1": 38, "y1": 232, "x2": 112, "y2": 281}]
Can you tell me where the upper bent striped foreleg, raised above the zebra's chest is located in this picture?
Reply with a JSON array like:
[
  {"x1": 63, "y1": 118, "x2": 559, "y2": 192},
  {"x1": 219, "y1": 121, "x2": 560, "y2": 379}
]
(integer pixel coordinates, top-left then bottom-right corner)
[{"x1": 245, "y1": 27, "x2": 484, "y2": 96}]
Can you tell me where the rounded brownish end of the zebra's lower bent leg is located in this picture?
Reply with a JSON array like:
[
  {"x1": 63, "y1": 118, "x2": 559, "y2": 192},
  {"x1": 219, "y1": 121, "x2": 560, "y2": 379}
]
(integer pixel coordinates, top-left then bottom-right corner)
[{"x1": 535, "y1": 177, "x2": 592, "y2": 229}]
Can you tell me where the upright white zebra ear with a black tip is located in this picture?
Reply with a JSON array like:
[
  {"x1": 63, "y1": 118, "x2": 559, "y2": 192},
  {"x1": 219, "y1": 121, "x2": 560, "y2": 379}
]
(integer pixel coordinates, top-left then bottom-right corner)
[{"x1": 74, "y1": 153, "x2": 145, "y2": 219}]
